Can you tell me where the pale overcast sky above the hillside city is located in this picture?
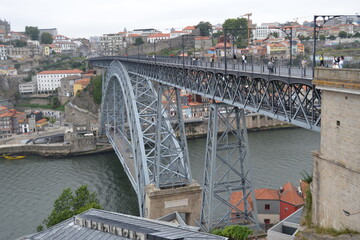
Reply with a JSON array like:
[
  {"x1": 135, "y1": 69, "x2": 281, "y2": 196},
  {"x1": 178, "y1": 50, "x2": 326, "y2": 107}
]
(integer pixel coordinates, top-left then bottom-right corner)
[{"x1": 0, "y1": 0, "x2": 360, "y2": 37}]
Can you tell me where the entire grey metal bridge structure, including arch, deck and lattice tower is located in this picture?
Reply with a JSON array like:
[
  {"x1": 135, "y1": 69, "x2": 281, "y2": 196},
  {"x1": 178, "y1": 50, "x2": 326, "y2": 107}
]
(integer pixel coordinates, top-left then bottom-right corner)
[{"x1": 90, "y1": 56, "x2": 321, "y2": 231}]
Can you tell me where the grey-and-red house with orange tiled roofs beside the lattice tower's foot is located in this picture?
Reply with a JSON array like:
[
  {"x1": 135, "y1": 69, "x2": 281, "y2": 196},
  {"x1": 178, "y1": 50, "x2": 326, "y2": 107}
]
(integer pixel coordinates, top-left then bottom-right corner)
[{"x1": 230, "y1": 182, "x2": 304, "y2": 224}]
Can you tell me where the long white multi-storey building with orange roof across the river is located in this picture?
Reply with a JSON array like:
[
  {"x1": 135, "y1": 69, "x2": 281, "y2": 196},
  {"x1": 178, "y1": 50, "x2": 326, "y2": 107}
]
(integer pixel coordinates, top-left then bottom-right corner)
[{"x1": 36, "y1": 69, "x2": 83, "y2": 93}]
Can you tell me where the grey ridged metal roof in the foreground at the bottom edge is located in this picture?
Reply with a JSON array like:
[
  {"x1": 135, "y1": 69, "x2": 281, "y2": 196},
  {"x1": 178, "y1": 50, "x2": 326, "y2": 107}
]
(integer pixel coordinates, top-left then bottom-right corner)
[{"x1": 23, "y1": 209, "x2": 226, "y2": 240}]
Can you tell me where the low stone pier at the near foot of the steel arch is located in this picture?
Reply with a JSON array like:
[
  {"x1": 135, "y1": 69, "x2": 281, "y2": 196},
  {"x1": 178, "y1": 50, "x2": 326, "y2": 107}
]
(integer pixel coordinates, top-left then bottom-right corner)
[{"x1": 145, "y1": 181, "x2": 202, "y2": 226}]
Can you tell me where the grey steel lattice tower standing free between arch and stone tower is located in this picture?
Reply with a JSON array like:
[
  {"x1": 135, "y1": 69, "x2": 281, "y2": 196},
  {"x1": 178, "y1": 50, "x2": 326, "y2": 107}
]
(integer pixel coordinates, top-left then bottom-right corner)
[{"x1": 200, "y1": 104, "x2": 258, "y2": 232}]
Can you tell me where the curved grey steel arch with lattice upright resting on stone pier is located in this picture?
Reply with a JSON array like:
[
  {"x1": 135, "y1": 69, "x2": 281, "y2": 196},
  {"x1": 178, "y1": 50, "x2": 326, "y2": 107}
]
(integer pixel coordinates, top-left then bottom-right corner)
[{"x1": 97, "y1": 61, "x2": 191, "y2": 216}]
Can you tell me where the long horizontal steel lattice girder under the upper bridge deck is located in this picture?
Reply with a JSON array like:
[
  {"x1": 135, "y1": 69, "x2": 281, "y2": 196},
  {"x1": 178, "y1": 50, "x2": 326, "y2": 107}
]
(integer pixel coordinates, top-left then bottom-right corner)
[{"x1": 112, "y1": 61, "x2": 321, "y2": 131}]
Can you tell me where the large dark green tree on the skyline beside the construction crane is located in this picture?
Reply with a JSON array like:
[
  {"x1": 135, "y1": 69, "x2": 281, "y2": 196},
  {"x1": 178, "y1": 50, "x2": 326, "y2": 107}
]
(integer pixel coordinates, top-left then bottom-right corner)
[{"x1": 223, "y1": 18, "x2": 248, "y2": 48}]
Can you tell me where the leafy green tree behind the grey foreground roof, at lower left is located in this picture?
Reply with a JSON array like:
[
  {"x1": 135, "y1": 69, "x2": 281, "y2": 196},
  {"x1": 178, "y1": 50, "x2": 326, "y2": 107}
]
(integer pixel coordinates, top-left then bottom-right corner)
[{"x1": 37, "y1": 185, "x2": 102, "y2": 230}]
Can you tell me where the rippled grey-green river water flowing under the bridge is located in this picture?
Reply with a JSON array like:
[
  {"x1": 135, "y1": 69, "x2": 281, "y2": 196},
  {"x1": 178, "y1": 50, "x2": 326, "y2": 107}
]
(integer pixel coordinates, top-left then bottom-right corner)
[{"x1": 0, "y1": 128, "x2": 320, "y2": 240}]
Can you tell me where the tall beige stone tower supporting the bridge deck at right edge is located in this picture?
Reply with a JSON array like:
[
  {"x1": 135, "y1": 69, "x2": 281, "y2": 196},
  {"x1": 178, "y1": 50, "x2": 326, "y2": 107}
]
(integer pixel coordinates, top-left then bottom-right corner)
[{"x1": 311, "y1": 68, "x2": 360, "y2": 231}]
